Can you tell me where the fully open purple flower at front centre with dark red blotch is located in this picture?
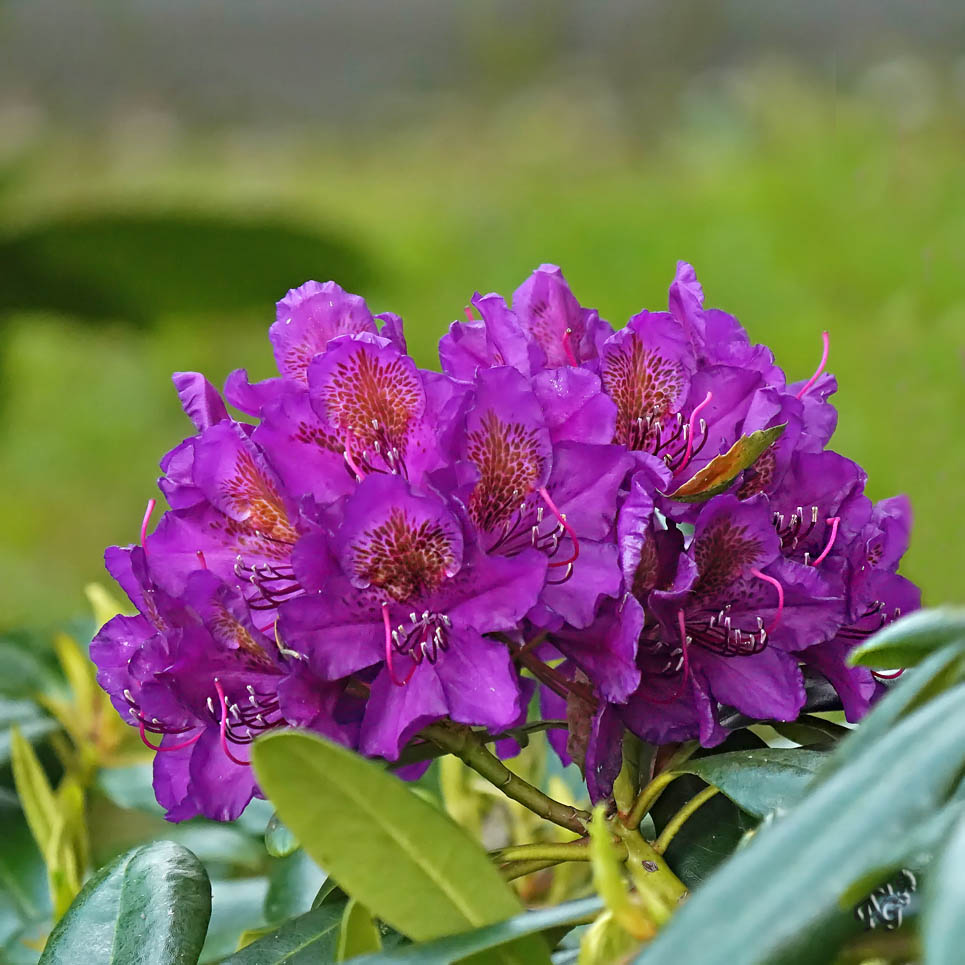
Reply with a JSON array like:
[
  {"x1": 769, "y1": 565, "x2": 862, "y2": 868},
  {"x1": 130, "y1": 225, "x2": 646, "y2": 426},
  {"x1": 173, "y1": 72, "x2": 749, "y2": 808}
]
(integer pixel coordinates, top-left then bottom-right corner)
[{"x1": 280, "y1": 474, "x2": 546, "y2": 760}]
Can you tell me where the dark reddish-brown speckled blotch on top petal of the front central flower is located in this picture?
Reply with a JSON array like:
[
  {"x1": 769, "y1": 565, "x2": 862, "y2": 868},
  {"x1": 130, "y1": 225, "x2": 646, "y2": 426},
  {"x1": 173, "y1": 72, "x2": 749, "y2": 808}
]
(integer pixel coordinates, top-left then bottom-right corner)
[{"x1": 352, "y1": 509, "x2": 456, "y2": 603}]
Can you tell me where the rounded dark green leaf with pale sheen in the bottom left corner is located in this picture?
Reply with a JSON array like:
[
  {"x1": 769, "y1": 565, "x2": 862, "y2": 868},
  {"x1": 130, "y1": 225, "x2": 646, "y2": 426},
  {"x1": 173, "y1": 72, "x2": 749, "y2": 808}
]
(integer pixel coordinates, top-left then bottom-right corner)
[{"x1": 40, "y1": 841, "x2": 211, "y2": 965}]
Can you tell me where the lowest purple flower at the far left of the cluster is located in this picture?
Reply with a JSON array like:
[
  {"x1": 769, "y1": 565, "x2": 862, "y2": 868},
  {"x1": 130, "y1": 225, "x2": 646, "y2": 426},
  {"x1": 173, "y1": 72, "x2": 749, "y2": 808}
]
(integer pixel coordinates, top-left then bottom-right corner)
[{"x1": 91, "y1": 547, "x2": 357, "y2": 821}]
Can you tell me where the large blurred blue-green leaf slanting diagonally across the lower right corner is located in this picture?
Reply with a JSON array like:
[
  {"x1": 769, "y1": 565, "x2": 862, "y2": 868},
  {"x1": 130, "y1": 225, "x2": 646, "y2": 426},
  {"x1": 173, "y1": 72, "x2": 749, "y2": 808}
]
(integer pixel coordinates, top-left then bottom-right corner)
[{"x1": 636, "y1": 686, "x2": 965, "y2": 965}]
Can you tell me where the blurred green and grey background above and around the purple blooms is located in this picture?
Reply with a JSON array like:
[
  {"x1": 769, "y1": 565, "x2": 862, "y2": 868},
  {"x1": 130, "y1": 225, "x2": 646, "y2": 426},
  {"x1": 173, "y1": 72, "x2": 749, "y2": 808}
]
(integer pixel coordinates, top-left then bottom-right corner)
[{"x1": 0, "y1": 0, "x2": 965, "y2": 628}]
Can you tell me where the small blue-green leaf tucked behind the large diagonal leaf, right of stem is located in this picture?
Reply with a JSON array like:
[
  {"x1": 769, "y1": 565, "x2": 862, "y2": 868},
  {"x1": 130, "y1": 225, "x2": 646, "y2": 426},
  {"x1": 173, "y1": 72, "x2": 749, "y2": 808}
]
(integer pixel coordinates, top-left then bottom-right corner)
[{"x1": 677, "y1": 747, "x2": 827, "y2": 818}]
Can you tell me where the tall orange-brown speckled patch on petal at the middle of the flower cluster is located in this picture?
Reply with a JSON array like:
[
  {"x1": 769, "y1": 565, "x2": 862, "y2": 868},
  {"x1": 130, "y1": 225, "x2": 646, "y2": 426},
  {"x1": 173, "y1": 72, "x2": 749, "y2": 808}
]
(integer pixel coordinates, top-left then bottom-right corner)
[{"x1": 467, "y1": 411, "x2": 545, "y2": 530}]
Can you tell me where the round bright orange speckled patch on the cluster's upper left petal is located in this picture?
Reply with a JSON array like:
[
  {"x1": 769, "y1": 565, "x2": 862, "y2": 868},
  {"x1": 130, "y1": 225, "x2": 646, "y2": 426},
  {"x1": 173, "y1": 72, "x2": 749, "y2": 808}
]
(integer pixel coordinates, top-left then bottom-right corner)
[{"x1": 325, "y1": 349, "x2": 425, "y2": 453}]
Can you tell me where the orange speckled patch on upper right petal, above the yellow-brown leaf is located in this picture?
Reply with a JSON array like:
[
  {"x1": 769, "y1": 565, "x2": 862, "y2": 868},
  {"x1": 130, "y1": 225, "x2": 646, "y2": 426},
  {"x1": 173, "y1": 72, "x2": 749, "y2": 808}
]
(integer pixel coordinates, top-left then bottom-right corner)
[{"x1": 602, "y1": 335, "x2": 686, "y2": 445}]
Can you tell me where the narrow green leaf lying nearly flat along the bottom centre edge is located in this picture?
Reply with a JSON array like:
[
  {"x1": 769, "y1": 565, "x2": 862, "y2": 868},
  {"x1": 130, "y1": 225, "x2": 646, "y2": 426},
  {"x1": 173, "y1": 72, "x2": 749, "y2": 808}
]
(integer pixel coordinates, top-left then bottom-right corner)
[{"x1": 344, "y1": 897, "x2": 604, "y2": 965}]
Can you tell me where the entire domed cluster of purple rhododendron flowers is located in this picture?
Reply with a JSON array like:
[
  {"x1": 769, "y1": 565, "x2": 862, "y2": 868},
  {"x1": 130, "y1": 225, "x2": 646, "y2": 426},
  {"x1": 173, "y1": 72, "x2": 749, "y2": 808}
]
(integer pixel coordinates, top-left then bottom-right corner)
[{"x1": 91, "y1": 262, "x2": 919, "y2": 820}]
